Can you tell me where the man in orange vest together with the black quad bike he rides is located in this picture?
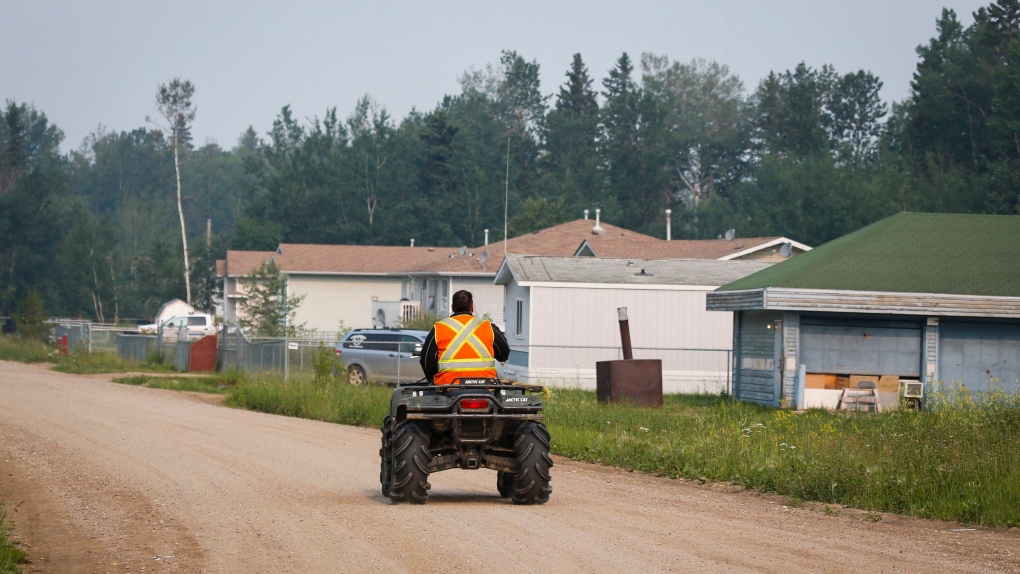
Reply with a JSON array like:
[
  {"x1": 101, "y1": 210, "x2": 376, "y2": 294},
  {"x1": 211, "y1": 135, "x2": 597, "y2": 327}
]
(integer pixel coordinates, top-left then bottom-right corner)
[{"x1": 379, "y1": 291, "x2": 553, "y2": 505}]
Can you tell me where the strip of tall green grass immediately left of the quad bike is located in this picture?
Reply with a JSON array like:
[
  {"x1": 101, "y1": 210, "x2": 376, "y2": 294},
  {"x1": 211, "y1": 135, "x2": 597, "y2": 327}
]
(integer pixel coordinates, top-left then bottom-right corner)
[{"x1": 226, "y1": 377, "x2": 393, "y2": 426}]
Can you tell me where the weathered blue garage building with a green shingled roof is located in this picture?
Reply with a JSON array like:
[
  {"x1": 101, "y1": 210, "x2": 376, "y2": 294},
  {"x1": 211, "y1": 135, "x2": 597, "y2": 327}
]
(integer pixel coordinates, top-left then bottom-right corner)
[{"x1": 707, "y1": 213, "x2": 1020, "y2": 408}]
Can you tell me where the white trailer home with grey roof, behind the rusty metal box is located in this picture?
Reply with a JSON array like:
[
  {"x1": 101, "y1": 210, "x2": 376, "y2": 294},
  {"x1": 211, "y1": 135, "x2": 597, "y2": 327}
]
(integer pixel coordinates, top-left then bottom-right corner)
[{"x1": 496, "y1": 255, "x2": 771, "y2": 393}]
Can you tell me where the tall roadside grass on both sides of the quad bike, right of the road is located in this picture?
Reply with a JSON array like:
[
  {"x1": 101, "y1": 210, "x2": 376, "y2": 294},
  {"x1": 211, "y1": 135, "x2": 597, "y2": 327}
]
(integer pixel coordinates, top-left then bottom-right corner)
[{"x1": 227, "y1": 378, "x2": 1020, "y2": 527}]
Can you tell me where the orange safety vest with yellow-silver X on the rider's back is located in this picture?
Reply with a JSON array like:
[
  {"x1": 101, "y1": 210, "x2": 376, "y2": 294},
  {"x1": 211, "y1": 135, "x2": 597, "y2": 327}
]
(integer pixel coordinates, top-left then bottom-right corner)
[{"x1": 432, "y1": 314, "x2": 497, "y2": 384}]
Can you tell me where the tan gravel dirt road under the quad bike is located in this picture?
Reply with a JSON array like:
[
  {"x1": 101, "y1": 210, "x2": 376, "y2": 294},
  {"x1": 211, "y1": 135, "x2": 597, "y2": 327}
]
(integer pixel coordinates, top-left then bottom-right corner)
[{"x1": 0, "y1": 362, "x2": 1020, "y2": 573}]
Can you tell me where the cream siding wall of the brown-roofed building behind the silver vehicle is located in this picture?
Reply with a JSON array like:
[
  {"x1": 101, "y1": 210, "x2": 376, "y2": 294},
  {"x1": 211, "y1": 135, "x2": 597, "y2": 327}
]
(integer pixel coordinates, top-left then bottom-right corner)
[{"x1": 288, "y1": 275, "x2": 401, "y2": 332}]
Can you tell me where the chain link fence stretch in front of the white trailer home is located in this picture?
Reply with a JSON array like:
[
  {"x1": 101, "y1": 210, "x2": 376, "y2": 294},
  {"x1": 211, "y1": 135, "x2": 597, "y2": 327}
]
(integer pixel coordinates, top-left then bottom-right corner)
[{"x1": 503, "y1": 345, "x2": 732, "y2": 394}]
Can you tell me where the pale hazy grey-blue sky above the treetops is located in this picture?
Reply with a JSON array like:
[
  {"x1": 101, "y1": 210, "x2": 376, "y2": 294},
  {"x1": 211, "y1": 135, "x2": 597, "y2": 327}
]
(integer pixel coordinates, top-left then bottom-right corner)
[{"x1": 0, "y1": 0, "x2": 990, "y2": 149}]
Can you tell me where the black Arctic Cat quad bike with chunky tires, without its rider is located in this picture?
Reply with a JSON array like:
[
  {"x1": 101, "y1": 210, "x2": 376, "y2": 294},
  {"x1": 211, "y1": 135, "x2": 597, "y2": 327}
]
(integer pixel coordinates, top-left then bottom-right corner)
[{"x1": 379, "y1": 379, "x2": 553, "y2": 505}]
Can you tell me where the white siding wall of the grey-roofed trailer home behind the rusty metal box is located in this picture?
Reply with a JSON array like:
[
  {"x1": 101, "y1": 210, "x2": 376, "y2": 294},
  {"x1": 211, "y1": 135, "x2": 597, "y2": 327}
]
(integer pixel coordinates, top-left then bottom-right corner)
[{"x1": 506, "y1": 282, "x2": 733, "y2": 393}]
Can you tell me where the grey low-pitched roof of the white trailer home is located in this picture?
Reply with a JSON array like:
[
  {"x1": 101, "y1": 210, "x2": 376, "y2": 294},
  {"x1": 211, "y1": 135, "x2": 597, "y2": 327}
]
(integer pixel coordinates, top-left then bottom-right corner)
[{"x1": 496, "y1": 254, "x2": 772, "y2": 286}]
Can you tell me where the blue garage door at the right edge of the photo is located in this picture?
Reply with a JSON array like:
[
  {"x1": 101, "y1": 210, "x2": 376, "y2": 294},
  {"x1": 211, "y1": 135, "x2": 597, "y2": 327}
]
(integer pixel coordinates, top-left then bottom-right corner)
[{"x1": 938, "y1": 320, "x2": 1020, "y2": 390}]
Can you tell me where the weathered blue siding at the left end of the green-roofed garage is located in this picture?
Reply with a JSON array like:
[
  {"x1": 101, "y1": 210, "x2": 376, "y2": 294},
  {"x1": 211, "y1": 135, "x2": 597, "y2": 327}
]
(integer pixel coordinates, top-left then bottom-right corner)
[{"x1": 733, "y1": 311, "x2": 782, "y2": 405}]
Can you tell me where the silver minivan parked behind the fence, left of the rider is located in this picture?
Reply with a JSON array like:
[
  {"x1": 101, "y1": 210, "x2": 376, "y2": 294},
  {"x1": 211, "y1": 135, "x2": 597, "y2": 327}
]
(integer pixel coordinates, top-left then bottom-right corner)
[{"x1": 337, "y1": 329, "x2": 428, "y2": 384}]
